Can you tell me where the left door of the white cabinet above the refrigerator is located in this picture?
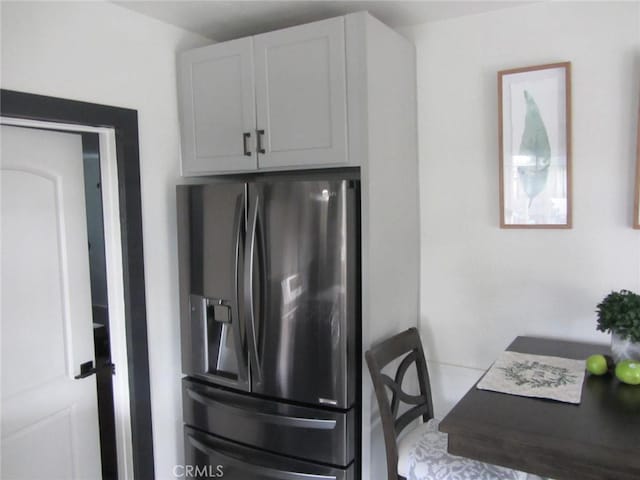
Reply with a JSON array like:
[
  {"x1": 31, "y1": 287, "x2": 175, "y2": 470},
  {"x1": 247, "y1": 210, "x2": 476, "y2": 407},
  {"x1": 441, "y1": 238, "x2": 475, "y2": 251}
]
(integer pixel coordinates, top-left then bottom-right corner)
[{"x1": 179, "y1": 38, "x2": 257, "y2": 175}]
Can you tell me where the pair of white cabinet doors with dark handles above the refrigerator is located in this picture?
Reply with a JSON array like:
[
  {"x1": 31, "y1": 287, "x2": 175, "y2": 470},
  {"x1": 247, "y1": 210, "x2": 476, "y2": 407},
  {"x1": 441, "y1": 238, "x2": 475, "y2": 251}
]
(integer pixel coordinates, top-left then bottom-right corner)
[{"x1": 179, "y1": 17, "x2": 349, "y2": 175}]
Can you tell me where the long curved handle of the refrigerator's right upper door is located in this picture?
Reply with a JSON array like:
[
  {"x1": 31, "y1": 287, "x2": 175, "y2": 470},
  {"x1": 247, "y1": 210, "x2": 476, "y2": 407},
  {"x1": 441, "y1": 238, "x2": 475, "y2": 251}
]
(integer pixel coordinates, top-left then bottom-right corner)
[{"x1": 244, "y1": 190, "x2": 262, "y2": 383}]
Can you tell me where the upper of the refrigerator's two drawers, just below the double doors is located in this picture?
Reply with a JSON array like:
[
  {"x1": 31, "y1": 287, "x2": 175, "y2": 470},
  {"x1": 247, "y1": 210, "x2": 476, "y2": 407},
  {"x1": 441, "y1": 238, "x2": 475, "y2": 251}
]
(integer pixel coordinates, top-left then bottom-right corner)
[{"x1": 182, "y1": 379, "x2": 355, "y2": 467}]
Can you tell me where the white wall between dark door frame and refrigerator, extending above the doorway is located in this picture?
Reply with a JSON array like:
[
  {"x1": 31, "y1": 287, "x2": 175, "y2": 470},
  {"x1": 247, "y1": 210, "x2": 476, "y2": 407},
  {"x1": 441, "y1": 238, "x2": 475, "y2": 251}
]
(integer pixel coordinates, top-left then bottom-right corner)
[{"x1": 1, "y1": 1, "x2": 211, "y2": 478}]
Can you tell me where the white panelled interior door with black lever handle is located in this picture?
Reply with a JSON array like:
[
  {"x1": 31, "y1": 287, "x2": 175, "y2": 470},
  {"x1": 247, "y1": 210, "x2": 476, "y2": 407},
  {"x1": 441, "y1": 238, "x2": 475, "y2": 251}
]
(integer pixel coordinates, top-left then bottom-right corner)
[{"x1": 0, "y1": 126, "x2": 101, "y2": 480}]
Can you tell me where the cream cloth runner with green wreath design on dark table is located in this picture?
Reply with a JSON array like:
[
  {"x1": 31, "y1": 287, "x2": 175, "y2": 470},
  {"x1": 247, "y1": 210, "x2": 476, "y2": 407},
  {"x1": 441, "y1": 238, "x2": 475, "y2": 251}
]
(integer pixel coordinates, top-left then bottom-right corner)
[{"x1": 478, "y1": 351, "x2": 585, "y2": 404}]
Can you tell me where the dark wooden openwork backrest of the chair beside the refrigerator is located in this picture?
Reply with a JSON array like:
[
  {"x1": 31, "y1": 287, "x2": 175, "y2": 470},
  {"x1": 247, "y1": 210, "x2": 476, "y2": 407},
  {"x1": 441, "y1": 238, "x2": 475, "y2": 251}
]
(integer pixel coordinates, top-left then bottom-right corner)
[{"x1": 365, "y1": 328, "x2": 433, "y2": 480}]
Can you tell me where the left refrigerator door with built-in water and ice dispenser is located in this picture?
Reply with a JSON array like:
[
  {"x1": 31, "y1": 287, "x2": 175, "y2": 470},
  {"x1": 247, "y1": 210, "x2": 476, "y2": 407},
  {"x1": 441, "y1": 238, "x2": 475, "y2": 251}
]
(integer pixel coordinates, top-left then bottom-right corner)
[{"x1": 178, "y1": 184, "x2": 250, "y2": 390}]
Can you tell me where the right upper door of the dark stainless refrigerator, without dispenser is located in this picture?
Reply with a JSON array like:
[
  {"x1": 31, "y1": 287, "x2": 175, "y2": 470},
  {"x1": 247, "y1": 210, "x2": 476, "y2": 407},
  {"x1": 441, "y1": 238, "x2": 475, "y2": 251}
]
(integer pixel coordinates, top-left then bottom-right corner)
[{"x1": 245, "y1": 180, "x2": 359, "y2": 409}]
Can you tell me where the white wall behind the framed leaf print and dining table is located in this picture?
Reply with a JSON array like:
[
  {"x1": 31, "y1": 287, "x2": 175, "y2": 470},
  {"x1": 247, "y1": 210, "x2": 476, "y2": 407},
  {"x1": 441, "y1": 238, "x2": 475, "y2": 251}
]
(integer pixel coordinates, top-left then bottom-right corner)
[{"x1": 405, "y1": 2, "x2": 640, "y2": 416}]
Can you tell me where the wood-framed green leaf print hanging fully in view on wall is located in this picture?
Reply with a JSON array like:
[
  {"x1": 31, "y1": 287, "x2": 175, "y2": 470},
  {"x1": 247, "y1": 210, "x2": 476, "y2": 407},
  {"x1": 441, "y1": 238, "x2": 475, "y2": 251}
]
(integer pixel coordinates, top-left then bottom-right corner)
[{"x1": 498, "y1": 62, "x2": 571, "y2": 228}]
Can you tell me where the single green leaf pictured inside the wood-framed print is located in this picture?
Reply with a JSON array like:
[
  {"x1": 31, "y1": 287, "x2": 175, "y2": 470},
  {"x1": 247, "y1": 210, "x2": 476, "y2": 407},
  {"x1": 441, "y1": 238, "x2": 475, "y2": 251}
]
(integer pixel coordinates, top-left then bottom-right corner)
[{"x1": 518, "y1": 90, "x2": 551, "y2": 207}]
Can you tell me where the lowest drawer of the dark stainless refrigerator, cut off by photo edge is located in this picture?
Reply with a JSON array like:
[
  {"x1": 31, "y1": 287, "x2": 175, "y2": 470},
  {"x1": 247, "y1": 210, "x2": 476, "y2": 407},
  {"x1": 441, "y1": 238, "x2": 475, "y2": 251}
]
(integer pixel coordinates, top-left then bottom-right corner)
[{"x1": 184, "y1": 426, "x2": 355, "y2": 480}]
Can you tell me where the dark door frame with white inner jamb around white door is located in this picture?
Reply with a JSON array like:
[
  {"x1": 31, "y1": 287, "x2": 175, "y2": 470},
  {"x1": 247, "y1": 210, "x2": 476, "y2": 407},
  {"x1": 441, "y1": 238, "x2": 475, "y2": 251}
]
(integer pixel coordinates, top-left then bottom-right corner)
[{"x1": 0, "y1": 89, "x2": 154, "y2": 479}]
